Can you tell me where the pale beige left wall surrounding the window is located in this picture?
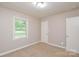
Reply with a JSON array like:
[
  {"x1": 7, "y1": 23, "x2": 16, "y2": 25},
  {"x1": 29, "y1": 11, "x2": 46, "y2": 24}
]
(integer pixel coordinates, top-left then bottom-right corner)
[{"x1": 0, "y1": 7, "x2": 41, "y2": 53}]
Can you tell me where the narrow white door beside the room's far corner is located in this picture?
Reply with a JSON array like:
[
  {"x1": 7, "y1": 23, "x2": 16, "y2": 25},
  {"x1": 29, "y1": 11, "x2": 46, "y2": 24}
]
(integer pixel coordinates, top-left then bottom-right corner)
[{"x1": 41, "y1": 21, "x2": 48, "y2": 43}]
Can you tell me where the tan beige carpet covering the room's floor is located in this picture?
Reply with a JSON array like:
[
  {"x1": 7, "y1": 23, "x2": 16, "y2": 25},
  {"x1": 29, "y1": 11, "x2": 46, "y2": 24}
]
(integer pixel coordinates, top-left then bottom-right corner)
[{"x1": 2, "y1": 42, "x2": 79, "y2": 57}]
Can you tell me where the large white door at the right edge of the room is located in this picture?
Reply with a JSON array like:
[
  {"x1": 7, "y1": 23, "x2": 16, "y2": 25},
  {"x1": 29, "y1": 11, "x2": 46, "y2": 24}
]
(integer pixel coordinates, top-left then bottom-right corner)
[{"x1": 66, "y1": 17, "x2": 79, "y2": 52}]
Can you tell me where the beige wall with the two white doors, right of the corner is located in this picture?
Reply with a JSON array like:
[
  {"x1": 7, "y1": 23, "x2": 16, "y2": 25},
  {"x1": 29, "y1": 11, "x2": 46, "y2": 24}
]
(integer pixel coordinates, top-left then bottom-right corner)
[{"x1": 41, "y1": 9, "x2": 79, "y2": 47}]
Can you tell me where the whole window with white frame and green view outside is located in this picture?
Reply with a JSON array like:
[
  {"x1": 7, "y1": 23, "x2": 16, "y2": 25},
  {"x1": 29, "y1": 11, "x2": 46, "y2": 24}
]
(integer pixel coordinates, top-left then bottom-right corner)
[{"x1": 14, "y1": 17, "x2": 28, "y2": 39}]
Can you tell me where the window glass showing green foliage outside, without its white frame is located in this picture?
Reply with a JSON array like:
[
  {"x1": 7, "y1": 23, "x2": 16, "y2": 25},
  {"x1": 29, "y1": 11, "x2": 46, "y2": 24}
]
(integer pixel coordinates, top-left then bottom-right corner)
[{"x1": 15, "y1": 18, "x2": 26, "y2": 38}]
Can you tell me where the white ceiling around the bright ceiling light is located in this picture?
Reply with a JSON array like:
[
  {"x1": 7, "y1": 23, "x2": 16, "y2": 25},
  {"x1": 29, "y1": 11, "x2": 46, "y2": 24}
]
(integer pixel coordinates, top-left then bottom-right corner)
[{"x1": 0, "y1": 2, "x2": 79, "y2": 18}]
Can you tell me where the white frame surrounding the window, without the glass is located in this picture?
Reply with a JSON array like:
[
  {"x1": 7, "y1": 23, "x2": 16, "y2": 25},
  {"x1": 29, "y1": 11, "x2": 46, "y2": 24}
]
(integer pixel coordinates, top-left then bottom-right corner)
[{"x1": 13, "y1": 16, "x2": 28, "y2": 40}]
